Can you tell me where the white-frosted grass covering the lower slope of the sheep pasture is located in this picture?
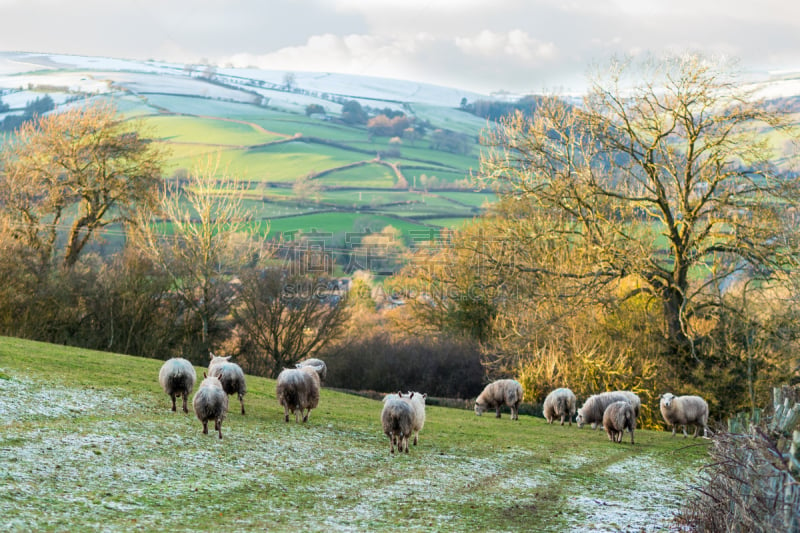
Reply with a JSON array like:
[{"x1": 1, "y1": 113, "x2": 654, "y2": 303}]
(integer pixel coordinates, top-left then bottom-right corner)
[{"x1": 0, "y1": 374, "x2": 700, "y2": 531}]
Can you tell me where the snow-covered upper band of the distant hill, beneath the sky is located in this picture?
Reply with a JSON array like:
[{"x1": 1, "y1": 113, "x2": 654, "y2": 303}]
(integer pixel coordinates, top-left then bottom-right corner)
[{"x1": 0, "y1": 52, "x2": 485, "y2": 109}]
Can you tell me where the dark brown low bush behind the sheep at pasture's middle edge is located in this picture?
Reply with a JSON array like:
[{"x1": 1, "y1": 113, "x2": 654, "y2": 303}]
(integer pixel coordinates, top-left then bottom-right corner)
[{"x1": 320, "y1": 330, "x2": 483, "y2": 398}]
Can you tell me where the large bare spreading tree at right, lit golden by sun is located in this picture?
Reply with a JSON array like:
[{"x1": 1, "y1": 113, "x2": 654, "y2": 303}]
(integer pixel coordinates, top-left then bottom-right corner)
[{"x1": 481, "y1": 56, "x2": 800, "y2": 364}]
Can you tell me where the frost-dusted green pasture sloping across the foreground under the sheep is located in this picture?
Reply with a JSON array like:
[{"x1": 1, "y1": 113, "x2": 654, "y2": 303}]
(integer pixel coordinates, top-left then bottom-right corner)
[{"x1": 0, "y1": 338, "x2": 707, "y2": 532}]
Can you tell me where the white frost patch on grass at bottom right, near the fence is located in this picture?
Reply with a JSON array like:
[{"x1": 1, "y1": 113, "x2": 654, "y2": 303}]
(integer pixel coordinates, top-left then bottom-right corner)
[{"x1": 569, "y1": 457, "x2": 688, "y2": 533}]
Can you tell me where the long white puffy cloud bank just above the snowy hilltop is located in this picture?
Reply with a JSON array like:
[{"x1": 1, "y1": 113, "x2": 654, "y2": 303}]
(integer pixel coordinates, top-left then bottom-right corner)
[{"x1": 224, "y1": 30, "x2": 559, "y2": 93}]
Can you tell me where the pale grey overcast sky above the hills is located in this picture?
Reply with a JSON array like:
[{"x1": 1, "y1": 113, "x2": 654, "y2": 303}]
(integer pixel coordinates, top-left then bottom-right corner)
[{"x1": 0, "y1": 0, "x2": 800, "y2": 93}]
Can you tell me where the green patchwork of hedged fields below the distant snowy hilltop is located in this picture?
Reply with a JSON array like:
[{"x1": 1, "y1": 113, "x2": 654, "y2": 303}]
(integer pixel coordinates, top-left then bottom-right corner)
[{"x1": 1, "y1": 82, "x2": 493, "y2": 256}]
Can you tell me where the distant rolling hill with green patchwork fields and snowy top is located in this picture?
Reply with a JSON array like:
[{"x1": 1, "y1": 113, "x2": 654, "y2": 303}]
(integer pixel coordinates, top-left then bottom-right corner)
[{"x1": 0, "y1": 53, "x2": 493, "y2": 260}]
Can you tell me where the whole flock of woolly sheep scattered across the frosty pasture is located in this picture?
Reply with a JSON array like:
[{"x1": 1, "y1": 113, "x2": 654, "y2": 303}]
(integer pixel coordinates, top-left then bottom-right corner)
[{"x1": 158, "y1": 354, "x2": 708, "y2": 453}]
